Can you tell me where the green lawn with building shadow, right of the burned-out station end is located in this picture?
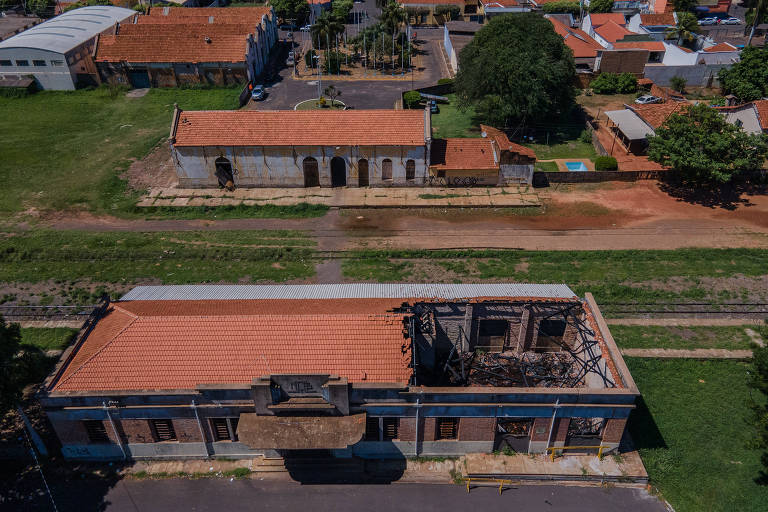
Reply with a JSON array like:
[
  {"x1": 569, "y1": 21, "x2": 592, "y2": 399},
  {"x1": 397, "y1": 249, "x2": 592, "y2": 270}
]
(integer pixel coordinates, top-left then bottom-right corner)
[{"x1": 626, "y1": 358, "x2": 768, "y2": 512}]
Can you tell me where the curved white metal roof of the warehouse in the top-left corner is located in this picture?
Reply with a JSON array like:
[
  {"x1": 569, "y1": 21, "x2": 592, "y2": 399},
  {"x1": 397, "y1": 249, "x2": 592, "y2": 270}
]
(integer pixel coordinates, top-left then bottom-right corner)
[{"x1": 0, "y1": 5, "x2": 137, "y2": 53}]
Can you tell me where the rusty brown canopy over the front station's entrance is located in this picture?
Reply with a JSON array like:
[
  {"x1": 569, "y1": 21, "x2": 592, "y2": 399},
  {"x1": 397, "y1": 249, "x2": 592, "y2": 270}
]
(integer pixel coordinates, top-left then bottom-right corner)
[{"x1": 237, "y1": 413, "x2": 365, "y2": 450}]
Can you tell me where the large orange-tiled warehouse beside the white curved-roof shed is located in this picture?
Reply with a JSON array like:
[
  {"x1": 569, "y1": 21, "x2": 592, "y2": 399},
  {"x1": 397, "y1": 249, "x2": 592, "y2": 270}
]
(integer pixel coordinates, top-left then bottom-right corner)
[{"x1": 94, "y1": 7, "x2": 277, "y2": 88}]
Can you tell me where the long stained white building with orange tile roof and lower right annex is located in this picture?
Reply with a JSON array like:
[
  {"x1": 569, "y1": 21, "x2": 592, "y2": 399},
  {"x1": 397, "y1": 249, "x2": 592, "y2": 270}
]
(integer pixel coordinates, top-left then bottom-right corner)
[{"x1": 170, "y1": 108, "x2": 536, "y2": 188}]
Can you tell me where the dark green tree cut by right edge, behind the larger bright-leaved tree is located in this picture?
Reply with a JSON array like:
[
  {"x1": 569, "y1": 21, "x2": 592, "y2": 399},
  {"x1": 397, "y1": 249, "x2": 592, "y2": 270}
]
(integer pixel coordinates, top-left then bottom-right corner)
[{"x1": 718, "y1": 46, "x2": 768, "y2": 102}]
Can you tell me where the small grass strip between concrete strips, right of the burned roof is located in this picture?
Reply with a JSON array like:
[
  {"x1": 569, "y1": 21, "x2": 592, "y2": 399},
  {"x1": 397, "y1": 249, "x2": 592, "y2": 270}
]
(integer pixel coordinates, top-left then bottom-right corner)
[{"x1": 611, "y1": 325, "x2": 756, "y2": 350}]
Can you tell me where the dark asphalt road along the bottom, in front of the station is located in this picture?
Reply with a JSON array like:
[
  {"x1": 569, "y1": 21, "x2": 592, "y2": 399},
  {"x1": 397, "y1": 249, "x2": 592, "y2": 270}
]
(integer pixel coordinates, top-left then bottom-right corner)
[{"x1": 96, "y1": 479, "x2": 666, "y2": 512}]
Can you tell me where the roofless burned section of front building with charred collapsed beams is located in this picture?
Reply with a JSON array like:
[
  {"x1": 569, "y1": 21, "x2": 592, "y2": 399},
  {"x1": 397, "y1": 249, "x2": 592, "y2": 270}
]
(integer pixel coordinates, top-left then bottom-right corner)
[{"x1": 411, "y1": 300, "x2": 620, "y2": 388}]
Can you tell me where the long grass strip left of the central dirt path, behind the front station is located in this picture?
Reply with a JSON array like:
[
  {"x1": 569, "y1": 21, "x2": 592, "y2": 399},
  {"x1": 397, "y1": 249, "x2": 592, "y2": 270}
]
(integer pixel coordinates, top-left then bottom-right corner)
[{"x1": 0, "y1": 230, "x2": 314, "y2": 285}]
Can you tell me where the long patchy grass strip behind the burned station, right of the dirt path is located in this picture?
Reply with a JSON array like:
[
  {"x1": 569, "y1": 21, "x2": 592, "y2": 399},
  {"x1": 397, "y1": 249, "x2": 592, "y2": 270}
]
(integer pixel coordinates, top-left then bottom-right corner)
[{"x1": 342, "y1": 249, "x2": 768, "y2": 303}]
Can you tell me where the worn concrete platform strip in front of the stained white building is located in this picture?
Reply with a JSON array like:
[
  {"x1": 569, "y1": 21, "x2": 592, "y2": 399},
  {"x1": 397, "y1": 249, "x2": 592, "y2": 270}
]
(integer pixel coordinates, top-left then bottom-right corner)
[{"x1": 138, "y1": 187, "x2": 541, "y2": 208}]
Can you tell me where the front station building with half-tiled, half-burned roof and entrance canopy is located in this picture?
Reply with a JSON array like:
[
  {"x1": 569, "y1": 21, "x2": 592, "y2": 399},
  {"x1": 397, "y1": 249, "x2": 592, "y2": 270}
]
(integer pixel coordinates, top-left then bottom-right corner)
[{"x1": 39, "y1": 283, "x2": 638, "y2": 459}]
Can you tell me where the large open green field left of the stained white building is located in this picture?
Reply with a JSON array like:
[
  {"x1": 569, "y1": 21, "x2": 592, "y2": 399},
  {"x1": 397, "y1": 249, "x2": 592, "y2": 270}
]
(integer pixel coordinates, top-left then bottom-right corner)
[{"x1": 0, "y1": 88, "x2": 239, "y2": 216}]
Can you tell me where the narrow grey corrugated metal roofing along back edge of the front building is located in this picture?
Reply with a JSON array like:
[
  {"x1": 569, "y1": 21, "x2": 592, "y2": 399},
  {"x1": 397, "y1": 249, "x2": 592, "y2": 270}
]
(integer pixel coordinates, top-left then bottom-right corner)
[{"x1": 120, "y1": 283, "x2": 576, "y2": 300}]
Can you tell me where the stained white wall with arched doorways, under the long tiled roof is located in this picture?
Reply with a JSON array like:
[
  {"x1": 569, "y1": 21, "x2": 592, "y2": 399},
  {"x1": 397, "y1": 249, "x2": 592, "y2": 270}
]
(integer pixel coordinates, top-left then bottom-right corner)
[{"x1": 171, "y1": 146, "x2": 428, "y2": 188}]
